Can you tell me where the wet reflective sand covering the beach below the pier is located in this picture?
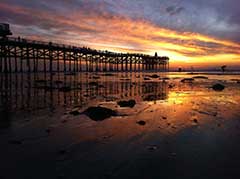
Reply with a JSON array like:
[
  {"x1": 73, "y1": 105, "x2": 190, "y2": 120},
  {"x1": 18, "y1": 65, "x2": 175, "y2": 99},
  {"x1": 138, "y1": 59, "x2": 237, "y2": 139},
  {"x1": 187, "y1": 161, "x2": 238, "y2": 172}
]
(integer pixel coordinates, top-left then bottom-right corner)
[{"x1": 0, "y1": 73, "x2": 240, "y2": 179}]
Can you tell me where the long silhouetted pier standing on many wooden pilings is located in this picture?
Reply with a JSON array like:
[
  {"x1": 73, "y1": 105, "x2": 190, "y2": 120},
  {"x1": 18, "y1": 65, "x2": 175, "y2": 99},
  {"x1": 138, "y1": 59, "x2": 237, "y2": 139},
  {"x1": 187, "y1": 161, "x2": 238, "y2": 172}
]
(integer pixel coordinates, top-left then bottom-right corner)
[{"x1": 0, "y1": 37, "x2": 169, "y2": 73}]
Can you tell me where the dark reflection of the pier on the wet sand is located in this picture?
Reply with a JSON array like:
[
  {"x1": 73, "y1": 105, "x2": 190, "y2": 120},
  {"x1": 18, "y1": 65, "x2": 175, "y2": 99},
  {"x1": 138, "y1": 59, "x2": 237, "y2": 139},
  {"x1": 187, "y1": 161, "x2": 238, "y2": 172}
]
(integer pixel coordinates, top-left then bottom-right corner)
[{"x1": 0, "y1": 73, "x2": 168, "y2": 111}]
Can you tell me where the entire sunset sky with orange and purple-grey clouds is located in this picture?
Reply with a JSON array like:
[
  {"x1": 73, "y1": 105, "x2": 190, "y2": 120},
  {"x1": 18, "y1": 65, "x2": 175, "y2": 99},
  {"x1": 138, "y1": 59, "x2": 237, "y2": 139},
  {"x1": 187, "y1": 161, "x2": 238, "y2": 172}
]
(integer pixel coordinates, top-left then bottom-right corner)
[{"x1": 0, "y1": 0, "x2": 240, "y2": 68}]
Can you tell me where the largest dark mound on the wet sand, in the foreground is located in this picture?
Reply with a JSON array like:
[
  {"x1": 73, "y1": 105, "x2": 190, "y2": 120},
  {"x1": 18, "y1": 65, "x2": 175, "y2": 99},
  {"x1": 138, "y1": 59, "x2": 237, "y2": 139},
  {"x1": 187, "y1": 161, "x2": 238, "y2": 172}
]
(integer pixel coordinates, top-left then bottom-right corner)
[{"x1": 83, "y1": 106, "x2": 117, "y2": 121}]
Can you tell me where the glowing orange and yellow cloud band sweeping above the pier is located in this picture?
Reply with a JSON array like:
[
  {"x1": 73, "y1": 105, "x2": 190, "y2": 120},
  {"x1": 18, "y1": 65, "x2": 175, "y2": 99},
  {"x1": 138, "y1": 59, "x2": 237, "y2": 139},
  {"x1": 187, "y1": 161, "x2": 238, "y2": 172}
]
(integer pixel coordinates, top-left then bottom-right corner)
[{"x1": 0, "y1": 3, "x2": 240, "y2": 66}]
